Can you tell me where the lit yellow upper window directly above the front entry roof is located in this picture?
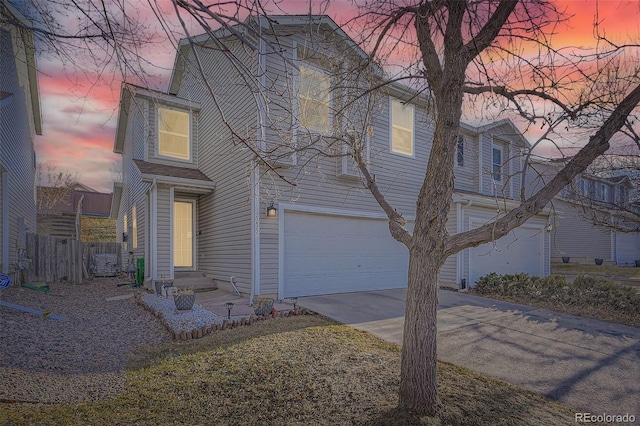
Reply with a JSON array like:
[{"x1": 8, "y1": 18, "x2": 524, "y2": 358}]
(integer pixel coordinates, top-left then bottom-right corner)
[{"x1": 158, "y1": 108, "x2": 191, "y2": 161}]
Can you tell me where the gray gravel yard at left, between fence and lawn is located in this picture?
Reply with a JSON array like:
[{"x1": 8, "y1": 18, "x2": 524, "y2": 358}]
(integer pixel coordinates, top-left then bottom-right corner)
[{"x1": 0, "y1": 278, "x2": 171, "y2": 403}]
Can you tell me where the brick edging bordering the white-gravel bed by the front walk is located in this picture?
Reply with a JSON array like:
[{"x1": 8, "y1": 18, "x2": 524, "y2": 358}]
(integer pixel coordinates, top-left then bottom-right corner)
[{"x1": 134, "y1": 290, "x2": 315, "y2": 341}]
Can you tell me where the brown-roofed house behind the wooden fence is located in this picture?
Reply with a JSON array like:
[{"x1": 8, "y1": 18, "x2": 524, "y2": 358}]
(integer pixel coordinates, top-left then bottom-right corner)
[{"x1": 37, "y1": 184, "x2": 116, "y2": 242}]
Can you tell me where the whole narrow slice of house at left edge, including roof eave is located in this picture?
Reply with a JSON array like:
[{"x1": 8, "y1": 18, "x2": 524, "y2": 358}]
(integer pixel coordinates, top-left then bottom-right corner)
[{"x1": 0, "y1": 1, "x2": 42, "y2": 280}]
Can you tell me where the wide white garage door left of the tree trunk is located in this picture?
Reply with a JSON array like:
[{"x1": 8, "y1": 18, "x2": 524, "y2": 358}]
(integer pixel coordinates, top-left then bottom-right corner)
[{"x1": 282, "y1": 212, "x2": 409, "y2": 297}]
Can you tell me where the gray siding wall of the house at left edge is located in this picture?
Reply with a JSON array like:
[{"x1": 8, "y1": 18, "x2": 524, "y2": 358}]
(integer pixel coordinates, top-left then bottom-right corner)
[{"x1": 0, "y1": 28, "x2": 36, "y2": 279}]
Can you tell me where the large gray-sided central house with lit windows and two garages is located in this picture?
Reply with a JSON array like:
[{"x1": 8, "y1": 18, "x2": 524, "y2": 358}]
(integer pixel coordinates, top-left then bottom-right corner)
[{"x1": 112, "y1": 16, "x2": 550, "y2": 298}]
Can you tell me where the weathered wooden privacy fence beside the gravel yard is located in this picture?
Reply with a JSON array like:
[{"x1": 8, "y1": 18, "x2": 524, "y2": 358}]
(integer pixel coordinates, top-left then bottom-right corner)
[{"x1": 23, "y1": 233, "x2": 122, "y2": 284}]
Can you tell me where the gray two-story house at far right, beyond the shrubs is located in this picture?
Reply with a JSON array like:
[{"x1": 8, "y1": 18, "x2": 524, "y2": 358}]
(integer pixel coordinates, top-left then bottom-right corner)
[{"x1": 527, "y1": 158, "x2": 640, "y2": 265}]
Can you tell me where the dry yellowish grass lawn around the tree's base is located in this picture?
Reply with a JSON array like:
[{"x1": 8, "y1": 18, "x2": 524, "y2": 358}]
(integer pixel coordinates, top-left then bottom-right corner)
[{"x1": 0, "y1": 316, "x2": 574, "y2": 425}]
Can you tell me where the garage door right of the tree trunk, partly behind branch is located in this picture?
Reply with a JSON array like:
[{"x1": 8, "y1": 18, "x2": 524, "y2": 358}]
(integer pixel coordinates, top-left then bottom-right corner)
[{"x1": 469, "y1": 228, "x2": 544, "y2": 285}]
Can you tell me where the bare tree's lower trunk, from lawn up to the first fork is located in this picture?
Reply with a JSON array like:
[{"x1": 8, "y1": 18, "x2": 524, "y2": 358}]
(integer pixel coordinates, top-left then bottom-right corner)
[{"x1": 399, "y1": 248, "x2": 442, "y2": 415}]
